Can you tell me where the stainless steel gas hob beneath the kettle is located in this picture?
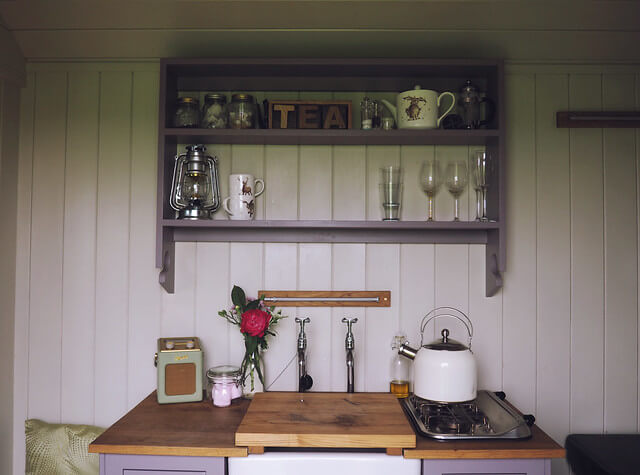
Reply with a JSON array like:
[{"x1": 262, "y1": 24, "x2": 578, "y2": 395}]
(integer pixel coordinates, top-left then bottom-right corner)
[{"x1": 402, "y1": 391, "x2": 535, "y2": 440}]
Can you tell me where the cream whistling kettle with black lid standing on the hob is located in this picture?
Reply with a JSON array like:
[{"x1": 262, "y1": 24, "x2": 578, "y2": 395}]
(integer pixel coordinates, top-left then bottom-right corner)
[{"x1": 398, "y1": 307, "x2": 478, "y2": 402}]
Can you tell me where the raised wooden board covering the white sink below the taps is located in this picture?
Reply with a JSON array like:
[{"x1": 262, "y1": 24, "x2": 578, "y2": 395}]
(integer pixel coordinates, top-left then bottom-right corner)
[{"x1": 236, "y1": 392, "x2": 416, "y2": 455}]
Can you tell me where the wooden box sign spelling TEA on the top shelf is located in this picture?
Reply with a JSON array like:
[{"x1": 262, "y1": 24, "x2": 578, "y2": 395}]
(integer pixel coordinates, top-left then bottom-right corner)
[{"x1": 267, "y1": 101, "x2": 351, "y2": 129}]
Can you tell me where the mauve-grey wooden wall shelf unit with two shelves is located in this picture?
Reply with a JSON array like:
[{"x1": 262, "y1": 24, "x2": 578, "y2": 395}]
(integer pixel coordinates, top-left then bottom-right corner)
[{"x1": 156, "y1": 58, "x2": 506, "y2": 296}]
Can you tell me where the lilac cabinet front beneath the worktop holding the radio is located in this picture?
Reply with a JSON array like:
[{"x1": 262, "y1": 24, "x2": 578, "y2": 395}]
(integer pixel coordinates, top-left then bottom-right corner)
[{"x1": 100, "y1": 454, "x2": 224, "y2": 475}]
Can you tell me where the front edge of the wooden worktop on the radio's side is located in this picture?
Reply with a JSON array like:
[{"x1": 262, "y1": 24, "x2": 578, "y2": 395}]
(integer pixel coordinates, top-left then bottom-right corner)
[{"x1": 89, "y1": 444, "x2": 248, "y2": 457}]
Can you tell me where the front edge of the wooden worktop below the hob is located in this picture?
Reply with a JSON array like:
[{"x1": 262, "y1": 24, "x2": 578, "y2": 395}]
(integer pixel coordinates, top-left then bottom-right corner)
[{"x1": 403, "y1": 447, "x2": 566, "y2": 459}]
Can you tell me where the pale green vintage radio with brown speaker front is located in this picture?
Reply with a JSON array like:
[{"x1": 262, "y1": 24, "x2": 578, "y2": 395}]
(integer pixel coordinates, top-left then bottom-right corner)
[{"x1": 155, "y1": 337, "x2": 202, "y2": 404}]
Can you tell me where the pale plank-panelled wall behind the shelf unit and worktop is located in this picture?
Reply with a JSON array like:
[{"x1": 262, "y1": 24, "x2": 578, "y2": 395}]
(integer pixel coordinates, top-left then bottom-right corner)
[{"x1": 8, "y1": 63, "x2": 640, "y2": 473}]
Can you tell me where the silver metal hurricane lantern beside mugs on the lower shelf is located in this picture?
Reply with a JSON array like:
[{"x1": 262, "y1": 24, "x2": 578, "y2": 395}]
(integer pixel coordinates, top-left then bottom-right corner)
[{"x1": 169, "y1": 145, "x2": 220, "y2": 219}]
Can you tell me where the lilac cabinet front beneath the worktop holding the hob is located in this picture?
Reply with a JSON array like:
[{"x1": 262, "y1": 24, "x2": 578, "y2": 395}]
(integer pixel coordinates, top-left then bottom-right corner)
[{"x1": 422, "y1": 459, "x2": 551, "y2": 475}]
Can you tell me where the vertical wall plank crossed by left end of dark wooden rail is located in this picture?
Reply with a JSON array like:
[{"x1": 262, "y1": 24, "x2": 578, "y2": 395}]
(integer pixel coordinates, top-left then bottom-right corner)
[{"x1": 536, "y1": 74, "x2": 571, "y2": 469}]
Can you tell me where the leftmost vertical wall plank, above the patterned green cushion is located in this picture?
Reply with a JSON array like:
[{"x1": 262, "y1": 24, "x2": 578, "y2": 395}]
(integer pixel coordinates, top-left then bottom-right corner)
[{"x1": 28, "y1": 72, "x2": 67, "y2": 421}]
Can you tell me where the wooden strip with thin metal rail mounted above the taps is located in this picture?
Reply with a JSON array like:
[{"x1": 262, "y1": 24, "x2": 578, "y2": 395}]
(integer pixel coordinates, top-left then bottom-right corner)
[{"x1": 258, "y1": 290, "x2": 391, "y2": 307}]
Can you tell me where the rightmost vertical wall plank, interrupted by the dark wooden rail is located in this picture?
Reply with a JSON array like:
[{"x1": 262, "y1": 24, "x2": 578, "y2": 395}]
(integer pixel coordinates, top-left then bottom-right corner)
[{"x1": 602, "y1": 74, "x2": 638, "y2": 432}]
